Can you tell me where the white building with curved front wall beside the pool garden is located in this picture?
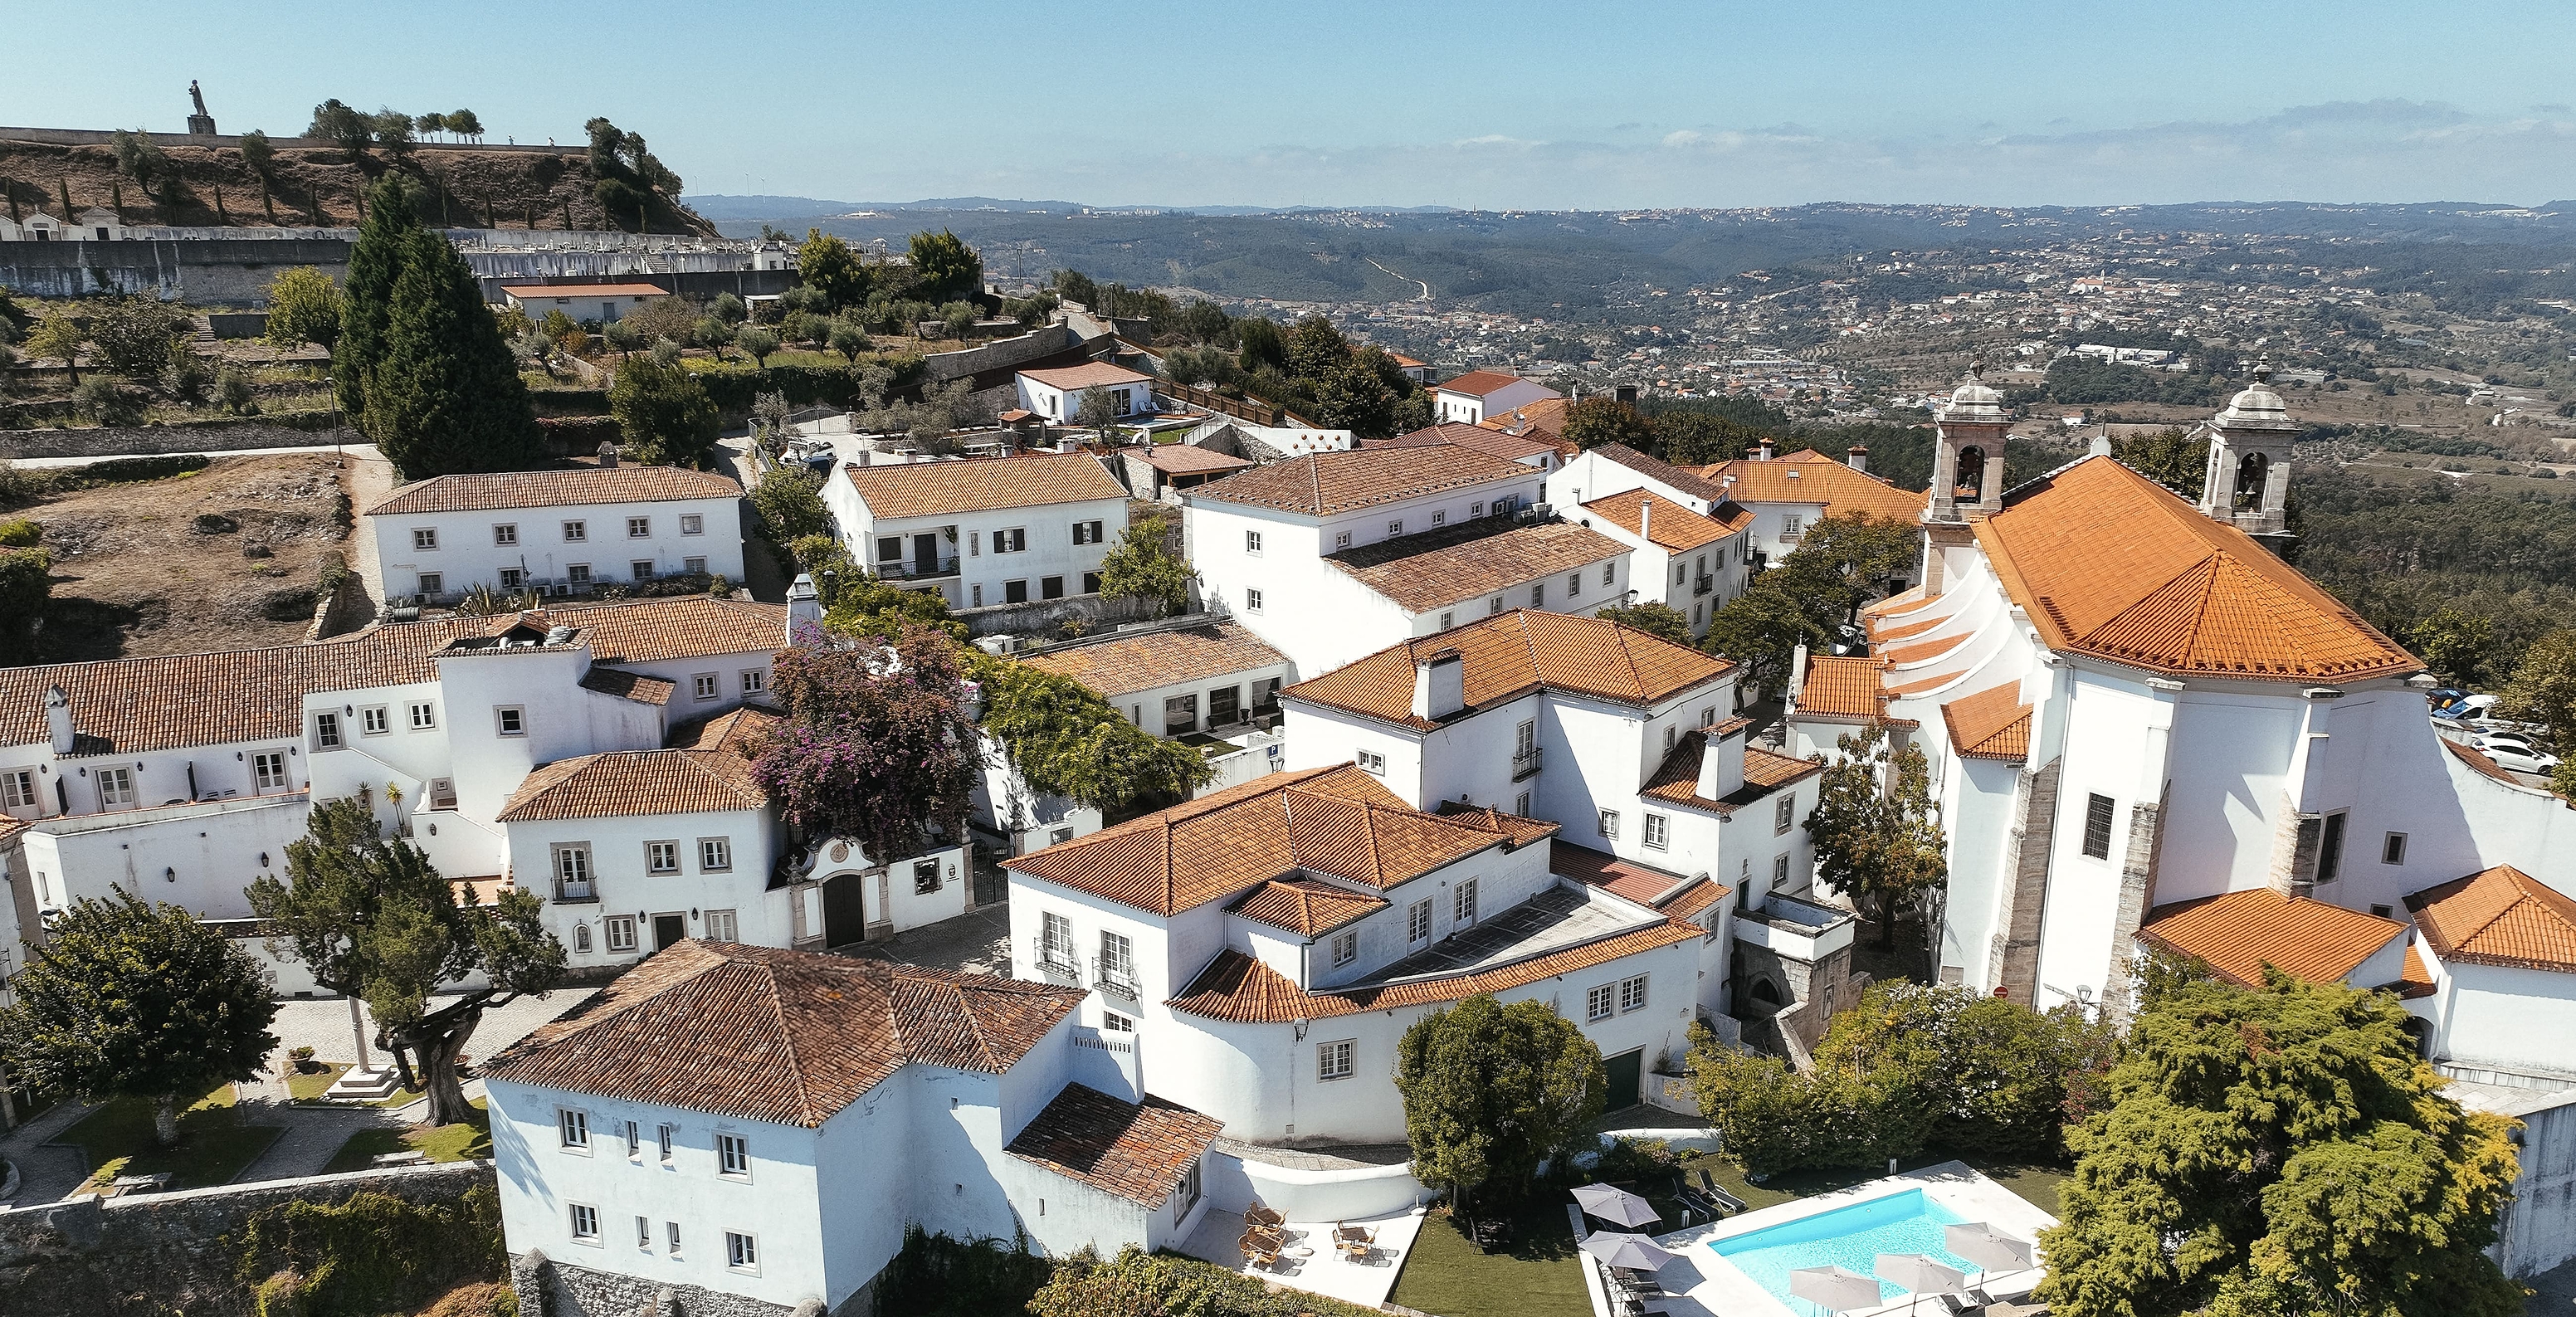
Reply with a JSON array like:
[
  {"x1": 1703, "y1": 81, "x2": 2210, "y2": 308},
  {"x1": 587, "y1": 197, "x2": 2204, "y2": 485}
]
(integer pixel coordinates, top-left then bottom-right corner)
[{"x1": 1010, "y1": 763, "x2": 1726, "y2": 1144}]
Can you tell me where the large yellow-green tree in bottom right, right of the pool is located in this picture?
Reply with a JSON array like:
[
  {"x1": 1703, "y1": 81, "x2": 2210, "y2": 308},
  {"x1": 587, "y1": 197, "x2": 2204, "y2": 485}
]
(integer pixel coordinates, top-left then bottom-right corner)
[{"x1": 2037, "y1": 972, "x2": 2522, "y2": 1317}]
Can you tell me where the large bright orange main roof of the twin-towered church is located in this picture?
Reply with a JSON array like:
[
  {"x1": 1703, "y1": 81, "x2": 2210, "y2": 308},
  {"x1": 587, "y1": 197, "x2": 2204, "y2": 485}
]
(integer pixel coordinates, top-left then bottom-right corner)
[{"x1": 1976, "y1": 456, "x2": 2424, "y2": 680}]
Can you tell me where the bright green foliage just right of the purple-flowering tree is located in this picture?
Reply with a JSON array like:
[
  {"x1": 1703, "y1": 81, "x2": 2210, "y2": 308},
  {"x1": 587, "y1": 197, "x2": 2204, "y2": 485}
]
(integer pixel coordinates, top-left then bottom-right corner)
[{"x1": 968, "y1": 655, "x2": 1216, "y2": 812}]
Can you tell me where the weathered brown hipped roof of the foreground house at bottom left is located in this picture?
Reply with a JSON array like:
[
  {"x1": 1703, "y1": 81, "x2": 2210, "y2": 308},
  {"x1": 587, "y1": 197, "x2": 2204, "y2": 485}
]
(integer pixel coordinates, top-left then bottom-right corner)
[{"x1": 481, "y1": 938, "x2": 1082, "y2": 1129}]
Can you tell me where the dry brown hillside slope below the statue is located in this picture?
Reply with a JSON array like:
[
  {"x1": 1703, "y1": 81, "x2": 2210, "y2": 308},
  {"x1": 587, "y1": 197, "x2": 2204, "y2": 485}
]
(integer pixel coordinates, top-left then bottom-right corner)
[{"x1": 0, "y1": 142, "x2": 716, "y2": 237}]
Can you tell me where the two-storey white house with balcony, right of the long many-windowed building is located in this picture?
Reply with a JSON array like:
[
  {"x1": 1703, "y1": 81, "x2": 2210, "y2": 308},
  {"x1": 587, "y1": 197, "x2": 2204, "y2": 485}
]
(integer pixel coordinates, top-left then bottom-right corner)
[{"x1": 822, "y1": 454, "x2": 1125, "y2": 608}]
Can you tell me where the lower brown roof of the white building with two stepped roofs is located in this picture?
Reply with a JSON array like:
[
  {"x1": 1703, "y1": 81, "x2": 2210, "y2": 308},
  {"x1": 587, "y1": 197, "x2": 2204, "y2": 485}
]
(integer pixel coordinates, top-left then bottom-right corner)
[{"x1": 1324, "y1": 518, "x2": 1628, "y2": 613}]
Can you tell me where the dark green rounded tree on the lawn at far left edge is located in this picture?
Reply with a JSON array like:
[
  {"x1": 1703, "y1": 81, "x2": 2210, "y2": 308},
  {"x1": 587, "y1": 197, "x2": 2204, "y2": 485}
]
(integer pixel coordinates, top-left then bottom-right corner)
[{"x1": 0, "y1": 892, "x2": 278, "y2": 1147}]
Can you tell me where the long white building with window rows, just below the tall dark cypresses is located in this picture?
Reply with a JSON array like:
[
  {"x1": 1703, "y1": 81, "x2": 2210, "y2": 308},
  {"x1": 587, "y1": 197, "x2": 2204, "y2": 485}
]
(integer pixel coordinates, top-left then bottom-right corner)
[{"x1": 366, "y1": 459, "x2": 742, "y2": 601}]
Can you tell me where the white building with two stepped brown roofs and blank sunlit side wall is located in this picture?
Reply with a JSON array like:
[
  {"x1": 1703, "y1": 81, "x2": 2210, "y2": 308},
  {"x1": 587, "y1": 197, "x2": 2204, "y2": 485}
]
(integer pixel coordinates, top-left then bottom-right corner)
[{"x1": 1183, "y1": 446, "x2": 1631, "y2": 678}]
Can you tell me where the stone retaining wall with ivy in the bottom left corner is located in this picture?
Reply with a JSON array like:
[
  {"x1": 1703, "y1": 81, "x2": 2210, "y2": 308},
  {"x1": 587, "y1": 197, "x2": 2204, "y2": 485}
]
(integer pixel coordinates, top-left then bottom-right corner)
[{"x1": 0, "y1": 1163, "x2": 495, "y2": 1317}]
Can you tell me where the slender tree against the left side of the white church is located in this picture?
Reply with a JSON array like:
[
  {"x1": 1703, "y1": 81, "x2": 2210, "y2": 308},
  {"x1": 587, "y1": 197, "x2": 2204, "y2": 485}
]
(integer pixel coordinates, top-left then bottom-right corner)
[{"x1": 1806, "y1": 722, "x2": 1950, "y2": 949}]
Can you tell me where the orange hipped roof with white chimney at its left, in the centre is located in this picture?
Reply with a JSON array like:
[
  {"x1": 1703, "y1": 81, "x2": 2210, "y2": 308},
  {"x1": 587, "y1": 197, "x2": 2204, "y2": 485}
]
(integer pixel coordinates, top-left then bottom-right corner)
[{"x1": 1281, "y1": 608, "x2": 1736, "y2": 729}]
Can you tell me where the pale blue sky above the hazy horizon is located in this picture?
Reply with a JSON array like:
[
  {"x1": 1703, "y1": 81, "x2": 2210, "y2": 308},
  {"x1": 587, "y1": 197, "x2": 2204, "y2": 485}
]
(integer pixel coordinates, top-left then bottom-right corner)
[{"x1": 0, "y1": 0, "x2": 2576, "y2": 209}]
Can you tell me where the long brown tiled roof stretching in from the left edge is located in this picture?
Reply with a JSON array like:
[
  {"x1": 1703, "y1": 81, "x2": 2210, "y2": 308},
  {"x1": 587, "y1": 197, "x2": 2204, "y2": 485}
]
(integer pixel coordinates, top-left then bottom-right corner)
[{"x1": 0, "y1": 595, "x2": 788, "y2": 755}]
